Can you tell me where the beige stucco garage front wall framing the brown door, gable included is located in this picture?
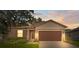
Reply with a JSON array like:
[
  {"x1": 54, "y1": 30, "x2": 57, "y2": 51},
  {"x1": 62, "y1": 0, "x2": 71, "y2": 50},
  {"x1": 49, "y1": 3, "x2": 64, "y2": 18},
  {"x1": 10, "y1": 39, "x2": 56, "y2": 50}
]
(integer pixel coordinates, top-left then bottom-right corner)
[{"x1": 35, "y1": 22, "x2": 65, "y2": 41}]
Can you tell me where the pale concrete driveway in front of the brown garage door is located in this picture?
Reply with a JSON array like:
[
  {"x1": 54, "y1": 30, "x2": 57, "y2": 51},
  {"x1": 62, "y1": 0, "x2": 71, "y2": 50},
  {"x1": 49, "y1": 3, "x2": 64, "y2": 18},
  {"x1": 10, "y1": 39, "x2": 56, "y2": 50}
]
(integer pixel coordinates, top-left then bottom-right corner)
[{"x1": 39, "y1": 41, "x2": 77, "y2": 48}]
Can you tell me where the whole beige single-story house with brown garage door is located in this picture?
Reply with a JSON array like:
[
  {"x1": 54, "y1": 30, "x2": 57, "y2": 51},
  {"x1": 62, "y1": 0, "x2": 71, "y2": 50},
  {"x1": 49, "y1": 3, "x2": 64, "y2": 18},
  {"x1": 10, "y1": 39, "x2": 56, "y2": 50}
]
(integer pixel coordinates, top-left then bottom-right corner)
[{"x1": 8, "y1": 20, "x2": 67, "y2": 41}]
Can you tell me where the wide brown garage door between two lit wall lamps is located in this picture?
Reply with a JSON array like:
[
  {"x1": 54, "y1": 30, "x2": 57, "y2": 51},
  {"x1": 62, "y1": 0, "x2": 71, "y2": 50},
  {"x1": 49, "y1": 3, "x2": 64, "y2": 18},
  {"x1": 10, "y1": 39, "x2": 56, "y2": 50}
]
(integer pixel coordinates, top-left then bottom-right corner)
[{"x1": 39, "y1": 31, "x2": 61, "y2": 41}]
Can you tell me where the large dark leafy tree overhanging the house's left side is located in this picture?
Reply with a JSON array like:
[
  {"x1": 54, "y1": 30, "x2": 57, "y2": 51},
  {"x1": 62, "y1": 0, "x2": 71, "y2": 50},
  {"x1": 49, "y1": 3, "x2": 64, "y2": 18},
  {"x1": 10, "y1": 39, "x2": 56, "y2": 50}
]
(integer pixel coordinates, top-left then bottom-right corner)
[{"x1": 0, "y1": 10, "x2": 34, "y2": 38}]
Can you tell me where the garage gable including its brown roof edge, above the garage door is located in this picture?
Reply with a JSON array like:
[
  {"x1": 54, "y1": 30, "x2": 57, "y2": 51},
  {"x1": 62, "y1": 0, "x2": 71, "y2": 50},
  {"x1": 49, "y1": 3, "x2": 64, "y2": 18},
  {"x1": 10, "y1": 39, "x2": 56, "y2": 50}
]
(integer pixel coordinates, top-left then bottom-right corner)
[{"x1": 35, "y1": 20, "x2": 66, "y2": 30}]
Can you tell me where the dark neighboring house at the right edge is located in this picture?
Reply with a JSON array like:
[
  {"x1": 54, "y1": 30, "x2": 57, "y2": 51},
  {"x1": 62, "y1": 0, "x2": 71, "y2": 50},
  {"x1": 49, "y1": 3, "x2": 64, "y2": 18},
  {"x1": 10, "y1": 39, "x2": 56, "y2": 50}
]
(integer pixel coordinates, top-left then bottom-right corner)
[{"x1": 68, "y1": 27, "x2": 79, "y2": 40}]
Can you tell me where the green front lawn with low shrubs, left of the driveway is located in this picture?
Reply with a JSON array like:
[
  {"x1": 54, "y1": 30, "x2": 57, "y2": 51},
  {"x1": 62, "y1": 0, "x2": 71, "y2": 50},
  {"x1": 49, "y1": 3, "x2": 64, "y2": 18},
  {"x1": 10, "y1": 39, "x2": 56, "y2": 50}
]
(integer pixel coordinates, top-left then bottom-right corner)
[{"x1": 0, "y1": 38, "x2": 39, "y2": 48}]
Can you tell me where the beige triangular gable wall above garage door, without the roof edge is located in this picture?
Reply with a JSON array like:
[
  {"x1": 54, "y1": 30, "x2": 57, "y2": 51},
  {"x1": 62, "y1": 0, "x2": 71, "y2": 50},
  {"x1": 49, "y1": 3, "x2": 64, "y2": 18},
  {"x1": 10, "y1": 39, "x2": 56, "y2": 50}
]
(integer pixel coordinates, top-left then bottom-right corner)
[{"x1": 36, "y1": 22, "x2": 64, "y2": 30}]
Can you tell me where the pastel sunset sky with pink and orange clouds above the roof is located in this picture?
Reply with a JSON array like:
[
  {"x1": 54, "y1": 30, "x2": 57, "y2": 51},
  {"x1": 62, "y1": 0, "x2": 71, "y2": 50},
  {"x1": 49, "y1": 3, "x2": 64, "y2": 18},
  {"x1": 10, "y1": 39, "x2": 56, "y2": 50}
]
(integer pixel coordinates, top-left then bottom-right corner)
[{"x1": 34, "y1": 10, "x2": 79, "y2": 29}]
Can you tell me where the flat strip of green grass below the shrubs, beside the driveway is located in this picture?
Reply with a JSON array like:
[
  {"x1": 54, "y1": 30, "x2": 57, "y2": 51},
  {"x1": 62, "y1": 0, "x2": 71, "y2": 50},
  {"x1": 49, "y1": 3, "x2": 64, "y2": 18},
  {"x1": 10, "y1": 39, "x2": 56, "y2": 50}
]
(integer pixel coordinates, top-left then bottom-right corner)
[{"x1": 0, "y1": 44, "x2": 39, "y2": 48}]
